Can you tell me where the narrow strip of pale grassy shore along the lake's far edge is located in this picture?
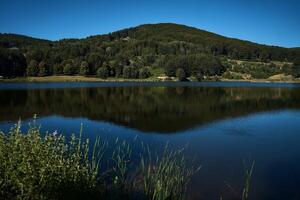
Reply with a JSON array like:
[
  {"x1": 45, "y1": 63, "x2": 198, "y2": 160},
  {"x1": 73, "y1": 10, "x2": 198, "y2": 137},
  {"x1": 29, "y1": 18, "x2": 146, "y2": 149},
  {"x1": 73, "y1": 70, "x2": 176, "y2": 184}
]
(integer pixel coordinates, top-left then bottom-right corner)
[{"x1": 0, "y1": 76, "x2": 300, "y2": 83}]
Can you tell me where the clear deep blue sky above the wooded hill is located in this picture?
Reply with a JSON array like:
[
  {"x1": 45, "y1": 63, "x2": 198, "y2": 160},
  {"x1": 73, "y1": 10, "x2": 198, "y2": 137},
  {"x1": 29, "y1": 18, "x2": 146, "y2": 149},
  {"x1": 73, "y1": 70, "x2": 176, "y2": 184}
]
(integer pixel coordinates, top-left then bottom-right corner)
[{"x1": 0, "y1": 0, "x2": 300, "y2": 47}]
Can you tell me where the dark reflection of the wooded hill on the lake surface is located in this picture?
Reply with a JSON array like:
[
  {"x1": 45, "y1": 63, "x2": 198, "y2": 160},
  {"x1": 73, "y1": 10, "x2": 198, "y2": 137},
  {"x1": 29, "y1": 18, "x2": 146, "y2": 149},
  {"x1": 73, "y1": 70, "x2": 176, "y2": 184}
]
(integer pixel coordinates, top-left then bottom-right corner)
[{"x1": 0, "y1": 87, "x2": 300, "y2": 132}]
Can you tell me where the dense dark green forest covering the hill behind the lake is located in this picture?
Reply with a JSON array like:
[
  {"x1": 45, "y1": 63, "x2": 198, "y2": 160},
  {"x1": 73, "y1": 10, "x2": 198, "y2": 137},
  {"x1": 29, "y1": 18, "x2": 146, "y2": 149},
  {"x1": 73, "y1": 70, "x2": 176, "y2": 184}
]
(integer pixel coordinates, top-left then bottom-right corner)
[{"x1": 0, "y1": 23, "x2": 300, "y2": 80}]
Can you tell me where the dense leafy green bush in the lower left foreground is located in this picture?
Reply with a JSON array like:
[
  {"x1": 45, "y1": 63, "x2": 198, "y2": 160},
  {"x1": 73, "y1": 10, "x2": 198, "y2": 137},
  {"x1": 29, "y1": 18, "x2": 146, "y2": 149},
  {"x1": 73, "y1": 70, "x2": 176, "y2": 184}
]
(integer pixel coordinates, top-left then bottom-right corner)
[{"x1": 0, "y1": 121, "x2": 99, "y2": 199}]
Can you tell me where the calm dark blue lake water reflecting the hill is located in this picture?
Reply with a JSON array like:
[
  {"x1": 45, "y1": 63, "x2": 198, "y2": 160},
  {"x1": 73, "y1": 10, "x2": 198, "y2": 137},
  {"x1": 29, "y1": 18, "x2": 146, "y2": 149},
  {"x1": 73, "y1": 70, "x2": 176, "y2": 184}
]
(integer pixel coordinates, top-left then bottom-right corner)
[{"x1": 0, "y1": 82, "x2": 300, "y2": 200}]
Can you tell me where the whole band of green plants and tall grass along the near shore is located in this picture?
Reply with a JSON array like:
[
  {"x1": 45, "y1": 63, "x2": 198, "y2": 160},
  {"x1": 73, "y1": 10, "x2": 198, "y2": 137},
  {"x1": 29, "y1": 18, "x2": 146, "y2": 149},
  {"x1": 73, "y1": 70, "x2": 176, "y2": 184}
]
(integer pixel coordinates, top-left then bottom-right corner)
[{"x1": 0, "y1": 121, "x2": 199, "y2": 200}]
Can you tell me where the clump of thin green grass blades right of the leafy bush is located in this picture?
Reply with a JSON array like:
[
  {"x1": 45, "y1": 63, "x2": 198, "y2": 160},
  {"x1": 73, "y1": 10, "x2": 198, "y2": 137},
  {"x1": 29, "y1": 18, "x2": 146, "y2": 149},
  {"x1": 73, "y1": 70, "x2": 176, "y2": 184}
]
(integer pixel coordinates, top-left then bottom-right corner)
[{"x1": 141, "y1": 145, "x2": 200, "y2": 200}]
